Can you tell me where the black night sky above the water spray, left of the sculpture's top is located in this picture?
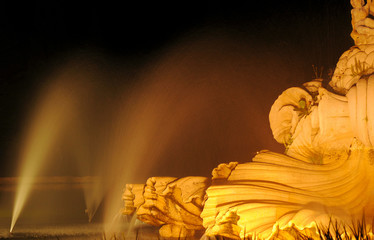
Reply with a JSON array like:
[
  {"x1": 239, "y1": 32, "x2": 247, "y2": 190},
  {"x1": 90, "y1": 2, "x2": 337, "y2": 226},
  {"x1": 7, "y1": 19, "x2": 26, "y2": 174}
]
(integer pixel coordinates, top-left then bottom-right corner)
[{"x1": 0, "y1": 0, "x2": 353, "y2": 176}]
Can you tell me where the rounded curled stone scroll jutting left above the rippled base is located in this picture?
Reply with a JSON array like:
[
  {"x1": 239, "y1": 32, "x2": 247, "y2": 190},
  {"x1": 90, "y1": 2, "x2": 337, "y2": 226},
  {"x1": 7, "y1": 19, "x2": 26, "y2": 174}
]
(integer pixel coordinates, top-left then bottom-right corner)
[{"x1": 269, "y1": 87, "x2": 313, "y2": 145}]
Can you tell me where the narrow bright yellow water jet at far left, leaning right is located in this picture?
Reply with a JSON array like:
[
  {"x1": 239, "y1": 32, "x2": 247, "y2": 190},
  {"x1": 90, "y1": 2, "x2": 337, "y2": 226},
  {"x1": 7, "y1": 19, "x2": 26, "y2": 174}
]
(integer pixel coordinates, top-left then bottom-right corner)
[{"x1": 10, "y1": 76, "x2": 90, "y2": 232}]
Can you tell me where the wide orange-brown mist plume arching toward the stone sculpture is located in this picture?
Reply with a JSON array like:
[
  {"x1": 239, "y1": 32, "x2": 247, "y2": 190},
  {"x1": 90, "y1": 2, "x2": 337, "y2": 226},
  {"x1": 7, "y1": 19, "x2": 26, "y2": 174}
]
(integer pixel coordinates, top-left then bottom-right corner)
[{"x1": 99, "y1": 31, "x2": 309, "y2": 231}]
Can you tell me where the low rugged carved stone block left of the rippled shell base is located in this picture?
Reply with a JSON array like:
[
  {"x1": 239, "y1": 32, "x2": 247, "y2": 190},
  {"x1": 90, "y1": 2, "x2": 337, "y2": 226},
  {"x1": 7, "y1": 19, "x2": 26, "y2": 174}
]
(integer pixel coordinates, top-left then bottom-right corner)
[{"x1": 123, "y1": 177, "x2": 209, "y2": 237}]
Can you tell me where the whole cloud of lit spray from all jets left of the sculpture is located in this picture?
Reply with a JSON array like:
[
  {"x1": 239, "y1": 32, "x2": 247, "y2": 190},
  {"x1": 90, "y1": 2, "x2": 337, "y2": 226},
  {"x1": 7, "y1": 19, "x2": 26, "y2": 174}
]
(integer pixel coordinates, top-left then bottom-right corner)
[{"x1": 11, "y1": 28, "x2": 310, "y2": 231}]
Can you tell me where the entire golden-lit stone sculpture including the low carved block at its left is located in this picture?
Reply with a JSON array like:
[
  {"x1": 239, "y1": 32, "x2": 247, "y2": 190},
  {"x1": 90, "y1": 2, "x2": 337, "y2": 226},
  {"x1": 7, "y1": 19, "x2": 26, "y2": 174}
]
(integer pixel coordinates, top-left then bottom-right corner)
[{"x1": 123, "y1": 0, "x2": 374, "y2": 239}]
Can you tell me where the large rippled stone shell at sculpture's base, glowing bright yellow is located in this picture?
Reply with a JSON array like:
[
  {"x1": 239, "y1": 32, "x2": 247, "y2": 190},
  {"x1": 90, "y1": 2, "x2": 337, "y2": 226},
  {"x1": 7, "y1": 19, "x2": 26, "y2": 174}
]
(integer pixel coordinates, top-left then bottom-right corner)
[{"x1": 201, "y1": 146, "x2": 374, "y2": 239}]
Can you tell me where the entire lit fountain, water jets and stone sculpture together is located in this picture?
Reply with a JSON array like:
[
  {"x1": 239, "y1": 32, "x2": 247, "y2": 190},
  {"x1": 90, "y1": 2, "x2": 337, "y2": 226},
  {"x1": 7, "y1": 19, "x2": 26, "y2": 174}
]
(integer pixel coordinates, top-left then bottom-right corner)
[{"x1": 5, "y1": 0, "x2": 368, "y2": 239}]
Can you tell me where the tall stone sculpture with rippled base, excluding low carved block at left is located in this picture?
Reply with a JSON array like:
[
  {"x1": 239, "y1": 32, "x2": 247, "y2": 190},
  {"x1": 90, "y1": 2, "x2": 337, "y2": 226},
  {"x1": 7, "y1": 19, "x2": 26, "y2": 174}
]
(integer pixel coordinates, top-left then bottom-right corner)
[{"x1": 201, "y1": 0, "x2": 374, "y2": 238}]
